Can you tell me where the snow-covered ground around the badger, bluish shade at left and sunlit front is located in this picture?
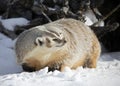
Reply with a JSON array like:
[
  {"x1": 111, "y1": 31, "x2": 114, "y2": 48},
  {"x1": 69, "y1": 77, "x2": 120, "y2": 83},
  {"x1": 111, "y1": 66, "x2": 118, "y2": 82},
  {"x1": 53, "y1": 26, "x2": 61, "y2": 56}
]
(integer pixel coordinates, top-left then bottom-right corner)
[{"x1": 0, "y1": 17, "x2": 120, "y2": 86}]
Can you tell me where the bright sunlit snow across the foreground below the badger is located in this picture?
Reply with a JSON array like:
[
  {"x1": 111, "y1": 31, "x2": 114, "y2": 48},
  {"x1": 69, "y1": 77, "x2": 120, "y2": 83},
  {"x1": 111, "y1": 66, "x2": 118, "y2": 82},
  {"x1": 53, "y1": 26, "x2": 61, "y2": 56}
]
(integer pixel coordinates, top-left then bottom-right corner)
[{"x1": 0, "y1": 61, "x2": 120, "y2": 86}]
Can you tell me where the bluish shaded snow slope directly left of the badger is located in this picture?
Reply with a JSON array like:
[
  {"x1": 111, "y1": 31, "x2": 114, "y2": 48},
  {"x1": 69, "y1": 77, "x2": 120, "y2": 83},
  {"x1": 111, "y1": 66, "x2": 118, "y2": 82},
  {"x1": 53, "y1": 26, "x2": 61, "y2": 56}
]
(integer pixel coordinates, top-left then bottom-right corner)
[{"x1": 0, "y1": 33, "x2": 22, "y2": 75}]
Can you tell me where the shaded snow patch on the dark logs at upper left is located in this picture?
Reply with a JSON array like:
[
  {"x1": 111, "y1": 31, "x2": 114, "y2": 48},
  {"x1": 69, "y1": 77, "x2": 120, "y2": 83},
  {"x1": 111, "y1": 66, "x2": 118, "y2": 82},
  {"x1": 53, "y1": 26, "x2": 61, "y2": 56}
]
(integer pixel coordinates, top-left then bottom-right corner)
[{"x1": 0, "y1": 18, "x2": 29, "y2": 31}]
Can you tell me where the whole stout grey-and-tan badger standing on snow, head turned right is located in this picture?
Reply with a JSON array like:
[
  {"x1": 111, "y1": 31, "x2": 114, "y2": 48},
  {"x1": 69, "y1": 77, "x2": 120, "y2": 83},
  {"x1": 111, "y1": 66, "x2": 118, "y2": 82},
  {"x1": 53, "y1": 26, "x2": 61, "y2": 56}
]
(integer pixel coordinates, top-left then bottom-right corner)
[{"x1": 15, "y1": 19, "x2": 101, "y2": 71}]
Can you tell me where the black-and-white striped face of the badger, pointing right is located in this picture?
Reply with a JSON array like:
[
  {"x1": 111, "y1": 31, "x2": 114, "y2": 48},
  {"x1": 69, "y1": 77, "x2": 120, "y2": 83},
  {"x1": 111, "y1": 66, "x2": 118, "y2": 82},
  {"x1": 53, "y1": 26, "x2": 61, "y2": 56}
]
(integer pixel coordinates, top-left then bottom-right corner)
[{"x1": 35, "y1": 26, "x2": 66, "y2": 48}]
